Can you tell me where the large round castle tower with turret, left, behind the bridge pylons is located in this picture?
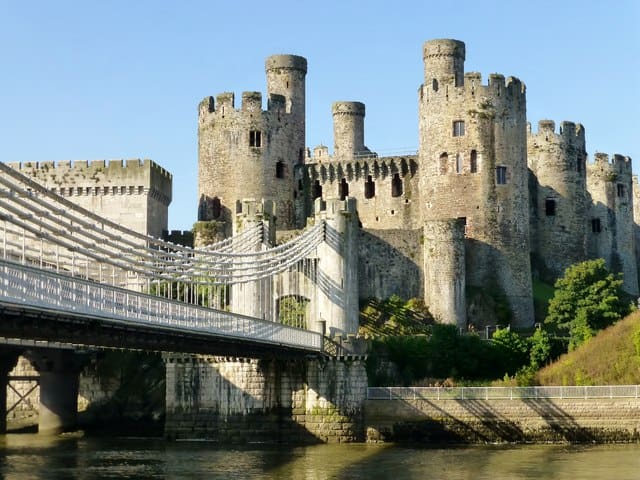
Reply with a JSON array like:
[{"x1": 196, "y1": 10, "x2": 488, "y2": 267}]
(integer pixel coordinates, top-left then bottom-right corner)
[{"x1": 198, "y1": 55, "x2": 307, "y2": 237}]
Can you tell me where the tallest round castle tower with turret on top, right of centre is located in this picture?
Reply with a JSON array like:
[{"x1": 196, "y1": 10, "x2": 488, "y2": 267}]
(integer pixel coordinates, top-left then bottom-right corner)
[{"x1": 418, "y1": 40, "x2": 534, "y2": 327}]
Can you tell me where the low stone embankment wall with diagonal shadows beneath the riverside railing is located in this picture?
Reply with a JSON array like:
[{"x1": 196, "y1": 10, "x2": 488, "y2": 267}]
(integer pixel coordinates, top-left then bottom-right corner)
[{"x1": 365, "y1": 398, "x2": 640, "y2": 443}]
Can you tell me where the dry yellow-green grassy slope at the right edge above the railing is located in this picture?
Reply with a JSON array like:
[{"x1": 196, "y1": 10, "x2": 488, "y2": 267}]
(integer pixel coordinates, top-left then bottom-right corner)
[{"x1": 537, "y1": 312, "x2": 640, "y2": 385}]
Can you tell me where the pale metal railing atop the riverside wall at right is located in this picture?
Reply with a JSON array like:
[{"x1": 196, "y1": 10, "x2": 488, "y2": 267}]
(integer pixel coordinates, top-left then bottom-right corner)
[{"x1": 367, "y1": 385, "x2": 640, "y2": 401}]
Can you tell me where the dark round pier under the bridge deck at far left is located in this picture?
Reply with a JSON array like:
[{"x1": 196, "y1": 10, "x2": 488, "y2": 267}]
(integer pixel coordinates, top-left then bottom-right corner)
[{"x1": 24, "y1": 349, "x2": 88, "y2": 435}]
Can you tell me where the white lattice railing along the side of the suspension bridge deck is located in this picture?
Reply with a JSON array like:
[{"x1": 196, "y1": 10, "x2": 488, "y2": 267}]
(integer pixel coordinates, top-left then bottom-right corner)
[{"x1": 0, "y1": 260, "x2": 322, "y2": 351}]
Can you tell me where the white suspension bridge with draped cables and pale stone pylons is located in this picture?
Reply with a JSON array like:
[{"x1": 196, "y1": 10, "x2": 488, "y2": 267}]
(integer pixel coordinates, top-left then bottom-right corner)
[{"x1": 0, "y1": 163, "x2": 358, "y2": 431}]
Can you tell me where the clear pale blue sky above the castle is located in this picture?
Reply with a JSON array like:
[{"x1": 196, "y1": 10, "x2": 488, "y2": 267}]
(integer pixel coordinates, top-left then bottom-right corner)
[{"x1": 0, "y1": 0, "x2": 640, "y2": 229}]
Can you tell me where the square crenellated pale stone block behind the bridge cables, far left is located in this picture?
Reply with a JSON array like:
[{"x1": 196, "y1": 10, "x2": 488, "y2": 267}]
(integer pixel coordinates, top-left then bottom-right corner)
[{"x1": 7, "y1": 159, "x2": 172, "y2": 238}]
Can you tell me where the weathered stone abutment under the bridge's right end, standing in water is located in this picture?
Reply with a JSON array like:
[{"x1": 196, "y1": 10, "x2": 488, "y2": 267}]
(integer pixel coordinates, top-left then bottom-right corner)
[{"x1": 165, "y1": 355, "x2": 367, "y2": 443}]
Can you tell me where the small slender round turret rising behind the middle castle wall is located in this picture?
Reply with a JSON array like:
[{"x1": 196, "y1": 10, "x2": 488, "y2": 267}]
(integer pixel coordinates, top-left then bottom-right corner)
[{"x1": 331, "y1": 102, "x2": 369, "y2": 160}]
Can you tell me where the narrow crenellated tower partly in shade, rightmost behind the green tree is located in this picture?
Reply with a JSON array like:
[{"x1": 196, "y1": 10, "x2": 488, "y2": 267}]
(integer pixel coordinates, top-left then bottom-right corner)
[{"x1": 587, "y1": 153, "x2": 638, "y2": 295}]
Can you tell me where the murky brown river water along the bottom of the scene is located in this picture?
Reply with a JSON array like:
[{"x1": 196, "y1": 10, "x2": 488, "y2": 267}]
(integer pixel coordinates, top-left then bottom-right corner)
[{"x1": 0, "y1": 434, "x2": 640, "y2": 480}]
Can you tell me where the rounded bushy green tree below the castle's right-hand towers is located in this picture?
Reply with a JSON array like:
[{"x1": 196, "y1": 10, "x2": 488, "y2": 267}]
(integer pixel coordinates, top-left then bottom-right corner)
[{"x1": 545, "y1": 258, "x2": 629, "y2": 349}]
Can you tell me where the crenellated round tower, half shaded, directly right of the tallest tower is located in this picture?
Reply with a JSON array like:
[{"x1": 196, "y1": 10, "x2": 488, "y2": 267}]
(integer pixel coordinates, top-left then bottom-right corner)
[{"x1": 527, "y1": 120, "x2": 587, "y2": 282}]
